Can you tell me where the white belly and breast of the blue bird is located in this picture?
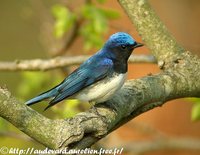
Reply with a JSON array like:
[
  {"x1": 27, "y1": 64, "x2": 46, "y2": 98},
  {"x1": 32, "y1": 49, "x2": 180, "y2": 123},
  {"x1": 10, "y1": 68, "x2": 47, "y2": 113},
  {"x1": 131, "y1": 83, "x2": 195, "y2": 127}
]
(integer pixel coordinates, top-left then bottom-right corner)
[{"x1": 74, "y1": 74, "x2": 126, "y2": 103}]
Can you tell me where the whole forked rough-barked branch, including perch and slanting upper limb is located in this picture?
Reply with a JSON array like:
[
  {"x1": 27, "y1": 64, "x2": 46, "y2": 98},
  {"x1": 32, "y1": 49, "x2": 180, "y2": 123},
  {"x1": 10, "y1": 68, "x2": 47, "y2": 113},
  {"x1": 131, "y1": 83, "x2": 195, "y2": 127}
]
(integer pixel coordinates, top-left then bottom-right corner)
[{"x1": 0, "y1": 0, "x2": 200, "y2": 151}]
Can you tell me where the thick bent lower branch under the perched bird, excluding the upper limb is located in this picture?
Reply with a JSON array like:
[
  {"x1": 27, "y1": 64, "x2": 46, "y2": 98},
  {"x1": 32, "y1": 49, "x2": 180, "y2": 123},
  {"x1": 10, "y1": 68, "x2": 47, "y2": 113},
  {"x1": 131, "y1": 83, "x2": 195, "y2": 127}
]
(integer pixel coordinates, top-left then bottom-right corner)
[{"x1": 0, "y1": 53, "x2": 200, "y2": 148}]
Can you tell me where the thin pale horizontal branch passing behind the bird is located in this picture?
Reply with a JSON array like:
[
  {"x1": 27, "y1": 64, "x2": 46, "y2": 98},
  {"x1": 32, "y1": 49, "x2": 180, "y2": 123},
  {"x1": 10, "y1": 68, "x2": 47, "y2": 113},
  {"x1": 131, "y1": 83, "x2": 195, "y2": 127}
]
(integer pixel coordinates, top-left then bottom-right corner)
[{"x1": 0, "y1": 55, "x2": 156, "y2": 71}]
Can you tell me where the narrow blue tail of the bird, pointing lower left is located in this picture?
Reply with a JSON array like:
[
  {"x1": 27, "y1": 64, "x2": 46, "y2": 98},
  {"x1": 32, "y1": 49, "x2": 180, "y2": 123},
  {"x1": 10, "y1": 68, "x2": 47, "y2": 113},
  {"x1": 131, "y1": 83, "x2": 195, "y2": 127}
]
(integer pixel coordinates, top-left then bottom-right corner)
[{"x1": 25, "y1": 88, "x2": 58, "y2": 106}]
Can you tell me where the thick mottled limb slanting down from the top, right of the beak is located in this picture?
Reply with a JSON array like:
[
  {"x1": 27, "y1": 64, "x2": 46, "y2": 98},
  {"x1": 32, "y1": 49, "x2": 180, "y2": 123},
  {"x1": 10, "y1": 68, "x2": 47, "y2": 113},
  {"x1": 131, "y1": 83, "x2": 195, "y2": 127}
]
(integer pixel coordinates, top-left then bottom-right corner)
[{"x1": 118, "y1": 0, "x2": 184, "y2": 61}]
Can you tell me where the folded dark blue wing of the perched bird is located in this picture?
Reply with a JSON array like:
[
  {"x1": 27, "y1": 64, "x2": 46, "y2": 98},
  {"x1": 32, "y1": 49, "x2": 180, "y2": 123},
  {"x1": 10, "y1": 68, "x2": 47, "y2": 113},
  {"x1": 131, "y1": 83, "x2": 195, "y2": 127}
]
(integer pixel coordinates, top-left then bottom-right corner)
[{"x1": 46, "y1": 58, "x2": 113, "y2": 109}]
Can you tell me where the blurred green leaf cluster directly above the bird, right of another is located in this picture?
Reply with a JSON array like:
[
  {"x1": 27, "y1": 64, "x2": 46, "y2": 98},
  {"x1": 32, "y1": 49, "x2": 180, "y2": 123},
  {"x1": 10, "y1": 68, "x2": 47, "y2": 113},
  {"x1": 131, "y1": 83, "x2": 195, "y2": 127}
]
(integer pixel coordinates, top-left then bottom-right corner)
[{"x1": 80, "y1": 5, "x2": 118, "y2": 50}]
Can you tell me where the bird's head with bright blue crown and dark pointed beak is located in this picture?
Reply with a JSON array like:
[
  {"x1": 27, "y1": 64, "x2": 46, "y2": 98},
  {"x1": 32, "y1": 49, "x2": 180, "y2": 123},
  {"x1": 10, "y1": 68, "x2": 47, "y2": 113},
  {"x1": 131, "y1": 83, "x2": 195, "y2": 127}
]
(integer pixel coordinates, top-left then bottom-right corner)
[{"x1": 103, "y1": 32, "x2": 143, "y2": 61}]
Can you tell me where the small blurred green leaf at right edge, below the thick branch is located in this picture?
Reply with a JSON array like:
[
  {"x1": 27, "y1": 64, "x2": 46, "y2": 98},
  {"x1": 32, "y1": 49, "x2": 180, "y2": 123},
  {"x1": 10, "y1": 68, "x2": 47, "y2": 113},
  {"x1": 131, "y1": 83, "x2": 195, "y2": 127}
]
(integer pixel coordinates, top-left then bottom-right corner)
[{"x1": 189, "y1": 98, "x2": 200, "y2": 121}]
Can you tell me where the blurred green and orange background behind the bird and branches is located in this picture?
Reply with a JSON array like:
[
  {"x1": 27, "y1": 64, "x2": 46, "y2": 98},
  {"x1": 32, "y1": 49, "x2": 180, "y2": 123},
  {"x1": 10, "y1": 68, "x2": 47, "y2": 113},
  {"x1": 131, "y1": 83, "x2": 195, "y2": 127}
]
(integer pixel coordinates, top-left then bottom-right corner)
[{"x1": 0, "y1": 0, "x2": 200, "y2": 155}]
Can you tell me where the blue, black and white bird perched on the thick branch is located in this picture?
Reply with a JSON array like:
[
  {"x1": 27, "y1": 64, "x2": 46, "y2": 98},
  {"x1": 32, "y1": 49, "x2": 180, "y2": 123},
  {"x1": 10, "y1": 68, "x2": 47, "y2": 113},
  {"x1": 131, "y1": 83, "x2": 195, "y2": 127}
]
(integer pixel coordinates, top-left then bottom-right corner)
[{"x1": 25, "y1": 32, "x2": 143, "y2": 110}]
